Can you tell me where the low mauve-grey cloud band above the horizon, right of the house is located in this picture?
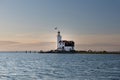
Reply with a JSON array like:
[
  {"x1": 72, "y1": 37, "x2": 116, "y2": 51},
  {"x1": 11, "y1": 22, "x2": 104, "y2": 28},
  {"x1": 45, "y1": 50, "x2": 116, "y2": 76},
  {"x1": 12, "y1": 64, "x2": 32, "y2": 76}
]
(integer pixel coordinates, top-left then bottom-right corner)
[{"x1": 76, "y1": 43, "x2": 120, "y2": 51}]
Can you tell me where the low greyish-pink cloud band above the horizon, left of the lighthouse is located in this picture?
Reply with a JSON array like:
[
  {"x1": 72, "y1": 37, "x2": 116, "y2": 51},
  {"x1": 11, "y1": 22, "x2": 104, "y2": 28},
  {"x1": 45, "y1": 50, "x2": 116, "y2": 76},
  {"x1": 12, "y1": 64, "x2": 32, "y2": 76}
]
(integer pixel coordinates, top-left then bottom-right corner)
[{"x1": 0, "y1": 41, "x2": 56, "y2": 51}]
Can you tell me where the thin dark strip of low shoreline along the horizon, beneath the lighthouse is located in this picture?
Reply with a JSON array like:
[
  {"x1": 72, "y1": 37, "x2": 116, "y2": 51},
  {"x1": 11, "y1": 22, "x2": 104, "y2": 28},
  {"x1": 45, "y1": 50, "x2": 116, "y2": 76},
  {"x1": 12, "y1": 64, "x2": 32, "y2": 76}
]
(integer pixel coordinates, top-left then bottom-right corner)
[{"x1": 0, "y1": 50, "x2": 120, "y2": 54}]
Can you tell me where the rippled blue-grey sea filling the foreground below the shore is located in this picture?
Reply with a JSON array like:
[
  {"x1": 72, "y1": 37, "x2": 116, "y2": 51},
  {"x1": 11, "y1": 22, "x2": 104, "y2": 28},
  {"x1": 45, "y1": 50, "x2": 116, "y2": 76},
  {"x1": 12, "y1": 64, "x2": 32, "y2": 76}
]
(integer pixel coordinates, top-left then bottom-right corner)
[{"x1": 0, "y1": 53, "x2": 120, "y2": 80}]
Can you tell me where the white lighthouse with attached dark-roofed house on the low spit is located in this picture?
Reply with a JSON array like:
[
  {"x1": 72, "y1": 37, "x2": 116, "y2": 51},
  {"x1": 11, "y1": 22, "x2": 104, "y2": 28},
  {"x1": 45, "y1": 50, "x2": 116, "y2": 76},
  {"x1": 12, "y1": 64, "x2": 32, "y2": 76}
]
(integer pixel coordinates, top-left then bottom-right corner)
[{"x1": 57, "y1": 31, "x2": 74, "y2": 51}]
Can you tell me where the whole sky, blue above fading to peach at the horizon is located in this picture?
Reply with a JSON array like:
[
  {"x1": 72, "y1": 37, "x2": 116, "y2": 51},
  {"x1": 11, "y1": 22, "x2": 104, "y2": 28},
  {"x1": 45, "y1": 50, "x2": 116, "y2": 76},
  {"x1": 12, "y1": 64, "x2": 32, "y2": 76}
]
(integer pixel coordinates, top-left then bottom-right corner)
[{"x1": 0, "y1": 0, "x2": 120, "y2": 51}]
